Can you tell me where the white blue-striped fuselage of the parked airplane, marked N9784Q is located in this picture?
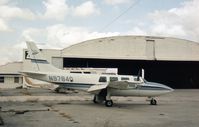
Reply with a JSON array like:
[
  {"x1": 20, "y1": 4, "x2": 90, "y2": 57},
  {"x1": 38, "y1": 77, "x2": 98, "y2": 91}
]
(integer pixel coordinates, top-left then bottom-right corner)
[{"x1": 29, "y1": 72, "x2": 173, "y2": 97}]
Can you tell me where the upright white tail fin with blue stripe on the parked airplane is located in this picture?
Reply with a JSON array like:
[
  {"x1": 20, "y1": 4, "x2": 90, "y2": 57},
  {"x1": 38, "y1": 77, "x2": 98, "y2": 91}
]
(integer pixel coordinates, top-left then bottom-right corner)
[{"x1": 26, "y1": 41, "x2": 62, "y2": 72}]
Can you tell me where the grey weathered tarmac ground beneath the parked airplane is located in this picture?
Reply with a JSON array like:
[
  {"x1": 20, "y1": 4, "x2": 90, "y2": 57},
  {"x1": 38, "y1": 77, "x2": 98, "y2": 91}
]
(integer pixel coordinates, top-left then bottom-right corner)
[{"x1": 0, "y1": 88, "x2": 199, "y2": 127}]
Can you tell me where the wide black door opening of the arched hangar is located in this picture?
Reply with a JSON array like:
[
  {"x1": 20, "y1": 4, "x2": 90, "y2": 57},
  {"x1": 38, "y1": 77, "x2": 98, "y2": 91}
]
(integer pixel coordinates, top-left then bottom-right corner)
[{"x1": 63, "y1": 58, "x2": 199, "y2": 89}]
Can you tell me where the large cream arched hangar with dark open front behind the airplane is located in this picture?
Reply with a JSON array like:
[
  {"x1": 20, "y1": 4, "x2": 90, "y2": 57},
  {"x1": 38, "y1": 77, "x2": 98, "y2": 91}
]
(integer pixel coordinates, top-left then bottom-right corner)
[{"x1": 60, "y1": 36, "x2": 199, "y2": 88}]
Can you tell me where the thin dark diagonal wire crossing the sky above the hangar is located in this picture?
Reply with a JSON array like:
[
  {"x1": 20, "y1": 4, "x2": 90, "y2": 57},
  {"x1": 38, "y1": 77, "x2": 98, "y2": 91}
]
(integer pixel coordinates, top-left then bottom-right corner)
[{"x1": 100, "y1": 0, "x2": 140, "y2": 32}]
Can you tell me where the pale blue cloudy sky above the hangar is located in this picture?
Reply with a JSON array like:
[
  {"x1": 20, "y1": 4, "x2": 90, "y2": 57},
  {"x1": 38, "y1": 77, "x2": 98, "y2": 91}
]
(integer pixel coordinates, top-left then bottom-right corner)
[{"x1": 0, "y1": 0, "x2": 199, "y2": 65}]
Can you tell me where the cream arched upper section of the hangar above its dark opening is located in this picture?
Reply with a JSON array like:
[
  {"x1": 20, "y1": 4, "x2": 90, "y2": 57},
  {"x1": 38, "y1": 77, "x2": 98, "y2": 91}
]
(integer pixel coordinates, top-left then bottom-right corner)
[{"x1": 61, "y1": 36, "x2": 199, "y2": 61}]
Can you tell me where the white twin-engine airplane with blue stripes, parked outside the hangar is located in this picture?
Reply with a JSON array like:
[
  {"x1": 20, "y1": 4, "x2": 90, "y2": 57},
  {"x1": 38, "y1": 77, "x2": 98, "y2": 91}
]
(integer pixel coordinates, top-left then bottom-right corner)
[{"x1": 22, "y1": 42, "x2": 173, "y2": 107}]
